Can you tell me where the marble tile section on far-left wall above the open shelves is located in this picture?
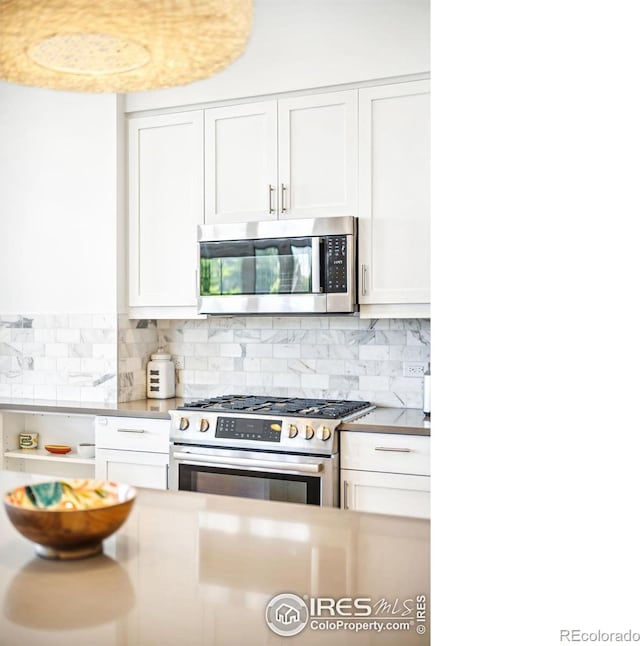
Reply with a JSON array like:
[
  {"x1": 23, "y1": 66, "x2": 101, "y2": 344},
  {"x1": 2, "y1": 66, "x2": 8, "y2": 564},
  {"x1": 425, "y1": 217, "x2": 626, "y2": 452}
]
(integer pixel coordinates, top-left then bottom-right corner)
[{"x1": 0, "y1": 314, "x2": 118, "y2": 402}]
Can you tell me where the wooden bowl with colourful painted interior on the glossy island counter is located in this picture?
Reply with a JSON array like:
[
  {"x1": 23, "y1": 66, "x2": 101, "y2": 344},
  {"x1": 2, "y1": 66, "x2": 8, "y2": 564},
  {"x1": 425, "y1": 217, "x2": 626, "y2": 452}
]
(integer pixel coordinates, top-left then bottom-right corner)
[{"x1": 4, "y1": 480, "x2": 136, "y2": 559}]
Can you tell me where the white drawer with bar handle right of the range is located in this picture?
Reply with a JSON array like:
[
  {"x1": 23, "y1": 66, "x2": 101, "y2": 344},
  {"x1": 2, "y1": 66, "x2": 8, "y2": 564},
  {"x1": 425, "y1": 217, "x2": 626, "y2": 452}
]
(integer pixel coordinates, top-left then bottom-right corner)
[{"x1": 340, "y1": 431, "x2": 431, "y2": 476}]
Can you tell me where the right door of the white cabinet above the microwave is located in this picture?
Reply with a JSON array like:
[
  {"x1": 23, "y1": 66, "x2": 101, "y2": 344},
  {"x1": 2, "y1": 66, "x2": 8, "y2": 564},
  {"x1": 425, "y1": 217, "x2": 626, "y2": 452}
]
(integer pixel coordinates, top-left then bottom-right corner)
[{"x1": 278, "y1": 90, "x2": 358, "y2": 218}]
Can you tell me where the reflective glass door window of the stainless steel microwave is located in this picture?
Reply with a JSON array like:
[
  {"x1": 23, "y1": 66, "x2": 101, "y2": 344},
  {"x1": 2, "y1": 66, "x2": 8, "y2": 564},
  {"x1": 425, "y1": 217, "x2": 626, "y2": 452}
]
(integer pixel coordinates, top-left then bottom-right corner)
[{"x1": 200, "y1": 238, "x2": 311, "y2": 296}]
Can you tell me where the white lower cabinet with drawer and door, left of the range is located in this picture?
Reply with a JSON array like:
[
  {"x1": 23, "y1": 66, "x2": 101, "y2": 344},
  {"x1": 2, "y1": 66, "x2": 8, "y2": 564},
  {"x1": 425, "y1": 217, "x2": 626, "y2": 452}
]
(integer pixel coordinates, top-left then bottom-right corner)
[{"x1": 96, "y1": 417, "x2": 170, "y2": 489}]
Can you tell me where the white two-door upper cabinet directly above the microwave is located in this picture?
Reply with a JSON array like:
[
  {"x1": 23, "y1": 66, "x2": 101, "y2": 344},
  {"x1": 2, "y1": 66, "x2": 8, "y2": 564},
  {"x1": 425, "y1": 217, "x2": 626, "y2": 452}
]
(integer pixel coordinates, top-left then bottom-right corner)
[{"x1": 205, "y1": 90, "x2": 358, "y2": 224}]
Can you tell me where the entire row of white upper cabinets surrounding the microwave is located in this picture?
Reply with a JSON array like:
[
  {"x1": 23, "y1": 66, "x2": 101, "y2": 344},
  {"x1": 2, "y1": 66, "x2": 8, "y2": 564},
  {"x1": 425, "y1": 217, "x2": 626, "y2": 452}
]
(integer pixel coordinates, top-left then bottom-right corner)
[{"x1": 129, "y1": 80, "x2": 431, "y2": 318}]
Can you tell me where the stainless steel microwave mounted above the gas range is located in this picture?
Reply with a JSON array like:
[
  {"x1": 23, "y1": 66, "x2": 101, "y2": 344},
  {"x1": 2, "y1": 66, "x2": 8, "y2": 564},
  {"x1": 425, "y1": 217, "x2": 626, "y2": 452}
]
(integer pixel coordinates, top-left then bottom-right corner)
[{"x1": 198, "y1": 216, "x2": 357, "y2": 314}]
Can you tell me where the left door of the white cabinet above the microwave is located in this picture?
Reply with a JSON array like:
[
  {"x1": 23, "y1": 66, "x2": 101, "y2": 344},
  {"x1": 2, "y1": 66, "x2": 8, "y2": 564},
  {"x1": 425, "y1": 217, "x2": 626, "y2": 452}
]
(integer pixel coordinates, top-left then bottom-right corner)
[{"x1": 205, "y1": 101, "x2": 278, "y2": 224}]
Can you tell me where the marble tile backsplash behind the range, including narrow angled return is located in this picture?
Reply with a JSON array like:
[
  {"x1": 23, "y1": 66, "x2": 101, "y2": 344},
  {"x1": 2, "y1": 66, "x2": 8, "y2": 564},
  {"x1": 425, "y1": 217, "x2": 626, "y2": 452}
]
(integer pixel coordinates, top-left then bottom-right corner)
[{"x1": 119, "y1": 316, "x2": 431, "y2": 408}]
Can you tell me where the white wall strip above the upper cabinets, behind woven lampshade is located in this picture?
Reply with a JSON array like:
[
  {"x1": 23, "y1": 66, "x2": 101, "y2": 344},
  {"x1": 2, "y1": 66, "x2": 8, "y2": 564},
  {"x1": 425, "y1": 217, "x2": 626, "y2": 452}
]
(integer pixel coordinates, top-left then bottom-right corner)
[{"x1": 125, "y1": 0, "x2": 430, "y2": 112}]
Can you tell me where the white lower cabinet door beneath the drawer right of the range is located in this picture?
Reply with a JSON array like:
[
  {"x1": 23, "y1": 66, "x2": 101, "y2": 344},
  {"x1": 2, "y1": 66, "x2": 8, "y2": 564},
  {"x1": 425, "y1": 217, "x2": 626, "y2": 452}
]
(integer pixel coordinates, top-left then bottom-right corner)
[{"x1": 340, "y1": 469, "x2": 431, "y2": 518}]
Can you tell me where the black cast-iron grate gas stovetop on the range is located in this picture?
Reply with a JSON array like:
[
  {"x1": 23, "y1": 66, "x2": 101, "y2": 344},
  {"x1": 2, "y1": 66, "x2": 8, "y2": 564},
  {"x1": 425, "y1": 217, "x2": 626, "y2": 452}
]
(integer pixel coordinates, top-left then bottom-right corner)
[{"x1": 178, "y1": 395, "x2": 371, "y2": 419}]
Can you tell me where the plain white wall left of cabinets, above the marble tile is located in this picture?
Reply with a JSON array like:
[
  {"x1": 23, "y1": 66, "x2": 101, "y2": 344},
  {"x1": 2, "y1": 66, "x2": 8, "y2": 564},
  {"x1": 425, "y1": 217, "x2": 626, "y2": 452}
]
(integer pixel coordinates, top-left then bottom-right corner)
[{"x1": 0, "y1": 82, "x2": 117, "y2": 314}]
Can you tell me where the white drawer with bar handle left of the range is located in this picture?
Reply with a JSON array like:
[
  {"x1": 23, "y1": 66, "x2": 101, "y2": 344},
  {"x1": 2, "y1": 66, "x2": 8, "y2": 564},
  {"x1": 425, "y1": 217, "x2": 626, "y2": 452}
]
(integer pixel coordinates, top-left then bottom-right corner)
[{"x1": 96, "y1": 417, "x2": 171, "y2": 453}]
